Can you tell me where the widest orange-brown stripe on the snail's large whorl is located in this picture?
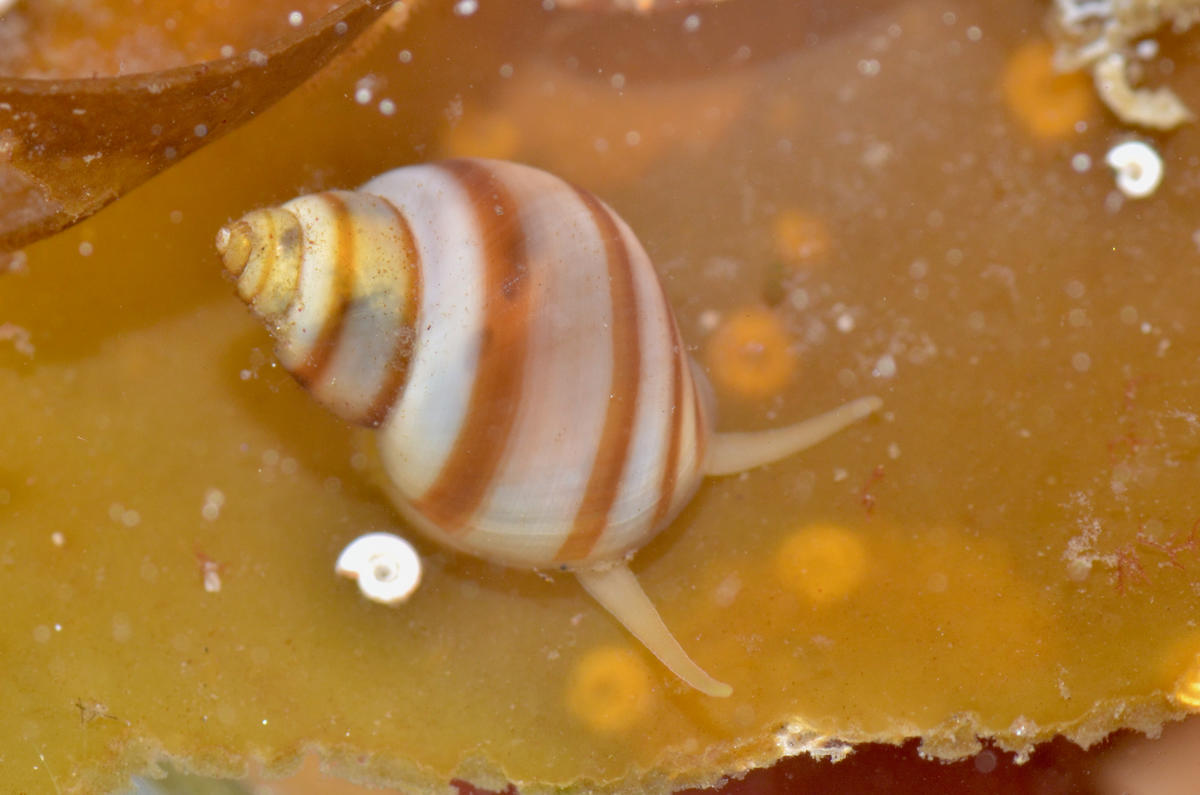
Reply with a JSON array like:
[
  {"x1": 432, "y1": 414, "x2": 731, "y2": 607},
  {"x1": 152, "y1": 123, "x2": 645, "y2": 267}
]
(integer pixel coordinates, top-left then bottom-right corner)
[{"x1": 414, "y1": 160, "x2": 533, "y2": 534}]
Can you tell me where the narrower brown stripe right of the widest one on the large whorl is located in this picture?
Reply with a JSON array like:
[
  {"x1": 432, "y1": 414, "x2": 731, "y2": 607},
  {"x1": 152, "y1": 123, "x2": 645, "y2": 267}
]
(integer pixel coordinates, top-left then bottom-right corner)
[{"x1": 556, "y1": 189, "x2": 642, "y2": 562}]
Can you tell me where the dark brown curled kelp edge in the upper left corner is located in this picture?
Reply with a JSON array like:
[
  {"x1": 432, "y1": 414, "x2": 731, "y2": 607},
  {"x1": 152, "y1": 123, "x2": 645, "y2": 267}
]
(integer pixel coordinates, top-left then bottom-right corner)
[{"x1": 0, "y1": 0, "x2": 391, "y2": 251}]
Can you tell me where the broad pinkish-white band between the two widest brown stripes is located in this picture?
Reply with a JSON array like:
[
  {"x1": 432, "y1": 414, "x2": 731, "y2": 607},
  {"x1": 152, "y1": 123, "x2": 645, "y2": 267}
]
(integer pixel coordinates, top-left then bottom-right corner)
[{"x1": 458, "y1": 162, "x2": 613, "y2": 566}]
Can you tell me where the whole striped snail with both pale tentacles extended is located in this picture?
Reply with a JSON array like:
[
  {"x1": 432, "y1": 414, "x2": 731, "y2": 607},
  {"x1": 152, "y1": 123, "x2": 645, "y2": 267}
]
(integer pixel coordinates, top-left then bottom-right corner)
[{"x1": 216, "y1": 160, "x2": 881, "y2": 695}]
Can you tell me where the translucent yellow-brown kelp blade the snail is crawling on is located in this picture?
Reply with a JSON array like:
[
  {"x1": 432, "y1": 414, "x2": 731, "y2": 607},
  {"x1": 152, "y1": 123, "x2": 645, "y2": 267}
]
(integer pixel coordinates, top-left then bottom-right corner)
[{"x1": 0, "y1": 1, "x2": 1200, "y2": 793}]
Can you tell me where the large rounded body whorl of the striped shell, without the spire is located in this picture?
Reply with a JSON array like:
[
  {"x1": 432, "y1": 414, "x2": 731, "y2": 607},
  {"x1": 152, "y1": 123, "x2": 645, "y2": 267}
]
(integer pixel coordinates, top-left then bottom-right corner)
[{"x1": 361, "y1": 160, "x2": 709, "y2": 568}]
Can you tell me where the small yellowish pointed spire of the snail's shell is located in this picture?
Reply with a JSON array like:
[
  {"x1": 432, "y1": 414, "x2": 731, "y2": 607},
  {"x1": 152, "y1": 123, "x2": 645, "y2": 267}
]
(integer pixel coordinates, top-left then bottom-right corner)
[{"x1": 217, "y1": 191, "x2": 420, "y2": 426}]
